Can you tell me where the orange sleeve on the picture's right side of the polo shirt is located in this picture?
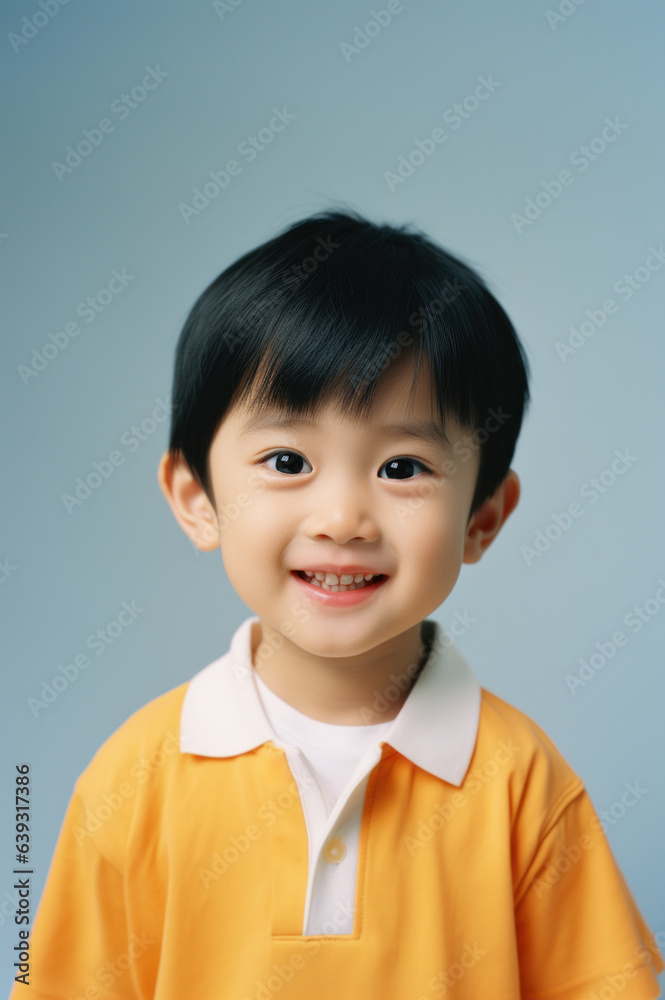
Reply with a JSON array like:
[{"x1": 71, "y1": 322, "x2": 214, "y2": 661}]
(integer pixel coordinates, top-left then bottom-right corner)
[{"x1": 515, "y1": 786, "x2": 665, "y2": 1000}]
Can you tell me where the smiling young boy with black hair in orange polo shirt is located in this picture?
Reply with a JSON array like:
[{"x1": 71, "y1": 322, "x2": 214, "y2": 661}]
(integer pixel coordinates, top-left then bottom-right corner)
[{"x1": 11, "y1": 212, "x2": 665, "y2": 1000}]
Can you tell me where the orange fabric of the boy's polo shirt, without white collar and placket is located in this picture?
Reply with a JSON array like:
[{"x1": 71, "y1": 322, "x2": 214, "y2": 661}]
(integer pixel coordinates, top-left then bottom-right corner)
[{"x1": 10, "y1": 620, "x2": 665, "y2": 1000}]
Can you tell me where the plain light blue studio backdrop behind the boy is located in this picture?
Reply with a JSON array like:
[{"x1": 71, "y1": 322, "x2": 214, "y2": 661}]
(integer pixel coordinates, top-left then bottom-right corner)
[{"x1": 0, "y1": 0, "x2": 665, "y2": 985}]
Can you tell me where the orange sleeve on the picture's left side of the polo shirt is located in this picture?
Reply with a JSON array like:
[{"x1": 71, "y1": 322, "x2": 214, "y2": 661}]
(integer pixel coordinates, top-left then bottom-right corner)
[{"x1": 9, "y1": 789, "x2": 138, "y2": 1000}]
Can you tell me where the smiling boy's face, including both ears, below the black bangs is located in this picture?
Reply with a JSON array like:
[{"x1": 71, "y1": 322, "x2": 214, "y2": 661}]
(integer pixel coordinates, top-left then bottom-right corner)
[{"x1": 160, "y1": 359, "x2": 519, "y2": 657}]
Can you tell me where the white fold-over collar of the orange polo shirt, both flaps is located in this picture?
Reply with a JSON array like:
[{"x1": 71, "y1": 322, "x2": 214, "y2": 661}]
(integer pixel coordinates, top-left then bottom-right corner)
[{"x1": 180, "y1": 615, "x2": 480, "y2": 785}]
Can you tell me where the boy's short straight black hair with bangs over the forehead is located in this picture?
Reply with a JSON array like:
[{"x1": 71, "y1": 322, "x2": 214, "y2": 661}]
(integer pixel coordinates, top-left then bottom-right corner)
[{"x1": 169, "y1": 210, "x2": 529, "y2": 518}]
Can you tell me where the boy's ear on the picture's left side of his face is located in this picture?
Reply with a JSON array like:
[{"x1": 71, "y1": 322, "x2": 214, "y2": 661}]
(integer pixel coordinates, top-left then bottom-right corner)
[{"x1": 157, "y1": 451, "x2": 220, "y2": 552}]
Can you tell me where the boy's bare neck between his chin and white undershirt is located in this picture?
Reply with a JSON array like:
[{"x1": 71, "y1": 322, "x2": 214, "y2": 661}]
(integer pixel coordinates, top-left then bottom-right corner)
[{"x1": 246, "y1": 619, "x2": 428, "y2": 726}]
